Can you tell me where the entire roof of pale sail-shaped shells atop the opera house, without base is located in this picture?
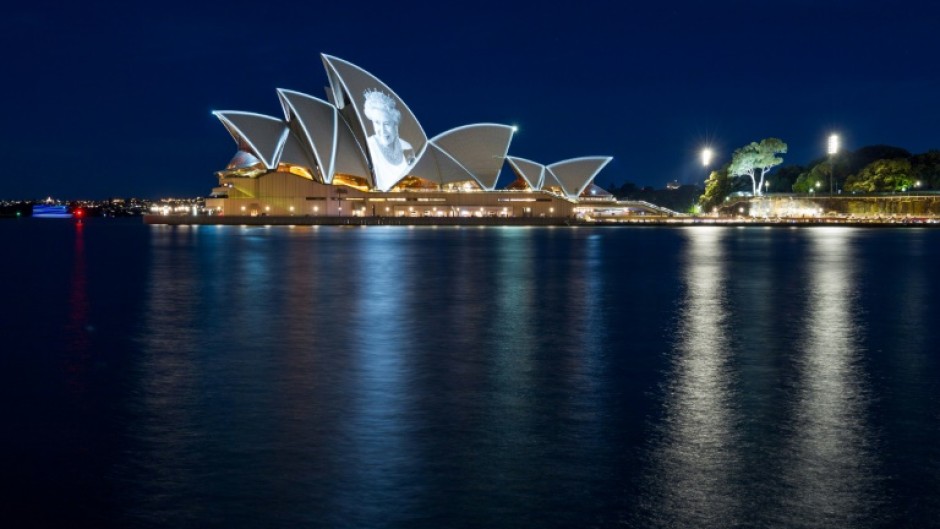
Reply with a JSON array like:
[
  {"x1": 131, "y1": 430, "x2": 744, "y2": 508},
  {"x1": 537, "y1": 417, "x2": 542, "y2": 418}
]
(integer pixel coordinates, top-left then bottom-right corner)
[{"x1": 214, "y1": 55, "x2": 611, "y2": 200}]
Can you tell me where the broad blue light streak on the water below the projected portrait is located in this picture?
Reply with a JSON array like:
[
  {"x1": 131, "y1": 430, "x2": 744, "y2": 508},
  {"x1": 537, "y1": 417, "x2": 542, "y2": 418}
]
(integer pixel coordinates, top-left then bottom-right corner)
[{"x1": 331, "y1": 230, "x2": 418, "y2": 527}]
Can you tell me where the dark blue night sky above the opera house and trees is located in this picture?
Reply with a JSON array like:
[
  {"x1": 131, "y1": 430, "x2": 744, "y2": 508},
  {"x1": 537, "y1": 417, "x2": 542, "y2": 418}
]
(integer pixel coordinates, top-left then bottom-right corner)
[{"x1": 0, "y1": 0, "x2": 940, "y2": 198}]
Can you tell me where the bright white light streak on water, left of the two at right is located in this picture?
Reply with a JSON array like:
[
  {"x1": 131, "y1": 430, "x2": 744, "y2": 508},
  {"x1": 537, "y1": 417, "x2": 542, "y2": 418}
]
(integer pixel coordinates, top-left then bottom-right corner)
[{"x1": 642, "y1": 228, "x2": 742, "y2": 527}]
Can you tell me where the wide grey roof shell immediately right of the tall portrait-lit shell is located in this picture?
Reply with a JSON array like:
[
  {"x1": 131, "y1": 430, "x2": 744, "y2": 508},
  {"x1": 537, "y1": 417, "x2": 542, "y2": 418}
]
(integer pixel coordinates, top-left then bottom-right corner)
[{"x1": 431, "y1": 123, "x2": 514, "y2": 191}]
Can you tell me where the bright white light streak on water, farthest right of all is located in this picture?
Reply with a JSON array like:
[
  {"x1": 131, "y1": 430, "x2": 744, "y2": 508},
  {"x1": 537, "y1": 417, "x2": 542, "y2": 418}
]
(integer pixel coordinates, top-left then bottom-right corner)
[{"x1": 770, "y1": 228, "x2": 879, "y2": 527}]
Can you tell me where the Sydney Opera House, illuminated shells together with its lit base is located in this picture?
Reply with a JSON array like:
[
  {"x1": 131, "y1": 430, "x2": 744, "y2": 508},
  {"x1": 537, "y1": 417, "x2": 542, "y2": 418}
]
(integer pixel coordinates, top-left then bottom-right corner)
[{"x1": 206, "y1": 55, "x2": 628, "y2": 218}]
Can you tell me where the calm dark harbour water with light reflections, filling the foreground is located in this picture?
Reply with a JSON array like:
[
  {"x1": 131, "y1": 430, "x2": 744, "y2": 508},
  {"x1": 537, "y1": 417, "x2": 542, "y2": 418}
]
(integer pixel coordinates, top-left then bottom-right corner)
[{"x1": 0, "y1": 219, "x2": 940, "y2": 528}]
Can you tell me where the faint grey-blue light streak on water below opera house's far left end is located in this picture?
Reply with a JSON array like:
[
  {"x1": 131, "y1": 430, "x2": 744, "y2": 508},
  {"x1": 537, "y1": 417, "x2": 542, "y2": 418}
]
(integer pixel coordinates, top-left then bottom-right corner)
[{"x1": 121, "y1": 227, "x2": 205, "y2": 525}]
